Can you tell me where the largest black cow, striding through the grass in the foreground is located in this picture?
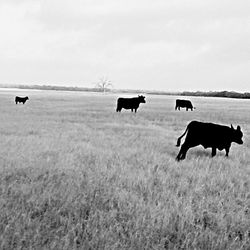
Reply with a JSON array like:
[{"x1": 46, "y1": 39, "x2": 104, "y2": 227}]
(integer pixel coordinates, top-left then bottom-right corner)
[{"x1": 176, "y1": 121, "x2": 243, "y2": 161}]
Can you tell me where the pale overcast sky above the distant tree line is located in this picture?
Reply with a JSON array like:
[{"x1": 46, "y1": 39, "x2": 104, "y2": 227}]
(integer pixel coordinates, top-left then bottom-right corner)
[{"x1": 0, "y1": 0, "x2": 250, "y2": 92}]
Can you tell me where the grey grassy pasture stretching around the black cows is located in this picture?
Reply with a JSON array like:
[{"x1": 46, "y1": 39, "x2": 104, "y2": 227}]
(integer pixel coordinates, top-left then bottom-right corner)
[{"x1": 0, "y1": 90, "x2": 250, "y2": 250}]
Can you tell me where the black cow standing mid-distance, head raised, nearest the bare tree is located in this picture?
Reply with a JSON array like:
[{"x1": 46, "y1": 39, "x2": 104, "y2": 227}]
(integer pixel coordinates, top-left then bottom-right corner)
[{"x1": 116, "y1": 95, "x2": 146, "y2": 113}]
